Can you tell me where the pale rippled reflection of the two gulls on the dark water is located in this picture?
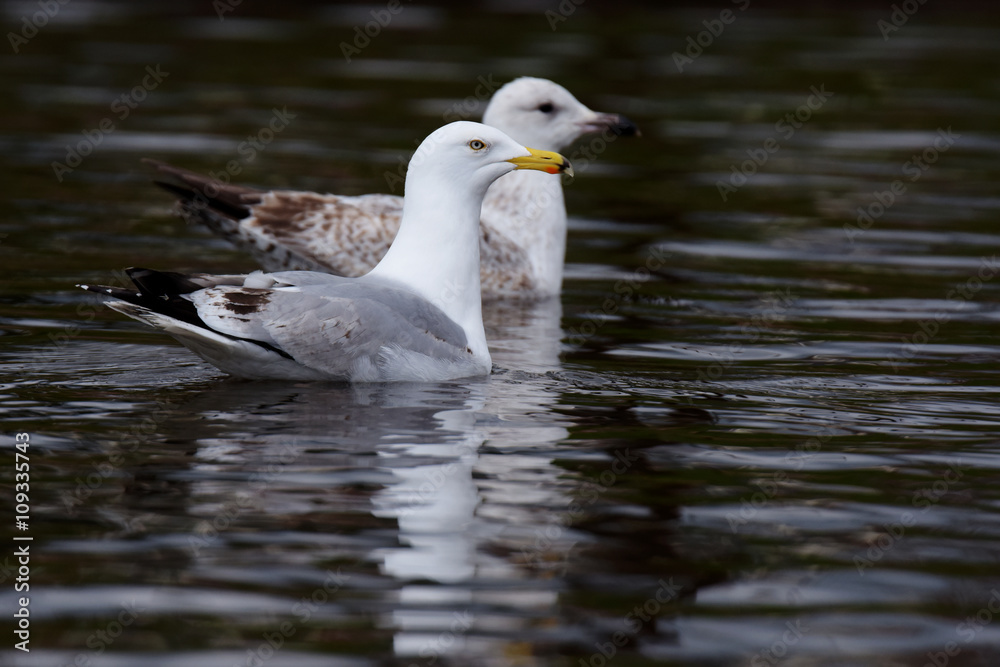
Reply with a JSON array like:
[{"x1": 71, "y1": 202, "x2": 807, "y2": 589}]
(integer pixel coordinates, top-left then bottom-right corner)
[{"x1": 142, "y1": 300, "x2": 572, "y2": 657}]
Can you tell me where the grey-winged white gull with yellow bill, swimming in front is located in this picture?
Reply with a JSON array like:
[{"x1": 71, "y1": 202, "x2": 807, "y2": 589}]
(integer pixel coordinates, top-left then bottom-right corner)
[{"x1": 80, "y1": 121, "x2": 572, "y2": 382}]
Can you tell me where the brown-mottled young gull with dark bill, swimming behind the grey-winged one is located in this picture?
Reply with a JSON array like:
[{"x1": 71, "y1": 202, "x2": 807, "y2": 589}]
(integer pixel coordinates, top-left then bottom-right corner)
[{"x1": 147, "y1": 77, "x2": 638, "y2": 299}]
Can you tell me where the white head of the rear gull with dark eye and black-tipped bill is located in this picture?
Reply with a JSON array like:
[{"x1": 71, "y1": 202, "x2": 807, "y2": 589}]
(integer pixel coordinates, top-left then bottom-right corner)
[{"x1": 483, "y1": 77, "x2": 639, "y2": 151}]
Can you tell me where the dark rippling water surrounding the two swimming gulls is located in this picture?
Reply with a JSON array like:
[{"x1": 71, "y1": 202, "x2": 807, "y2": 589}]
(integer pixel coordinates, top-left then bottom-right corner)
[{"x1": 0, "y1": 0, "x2": 1000, "y2": 667}]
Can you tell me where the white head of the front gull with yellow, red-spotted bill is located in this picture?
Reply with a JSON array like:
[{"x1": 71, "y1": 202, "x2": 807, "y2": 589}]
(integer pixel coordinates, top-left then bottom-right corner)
[{"x1": 406, "y1": 121, "x2": 573, "y2": 197}]
